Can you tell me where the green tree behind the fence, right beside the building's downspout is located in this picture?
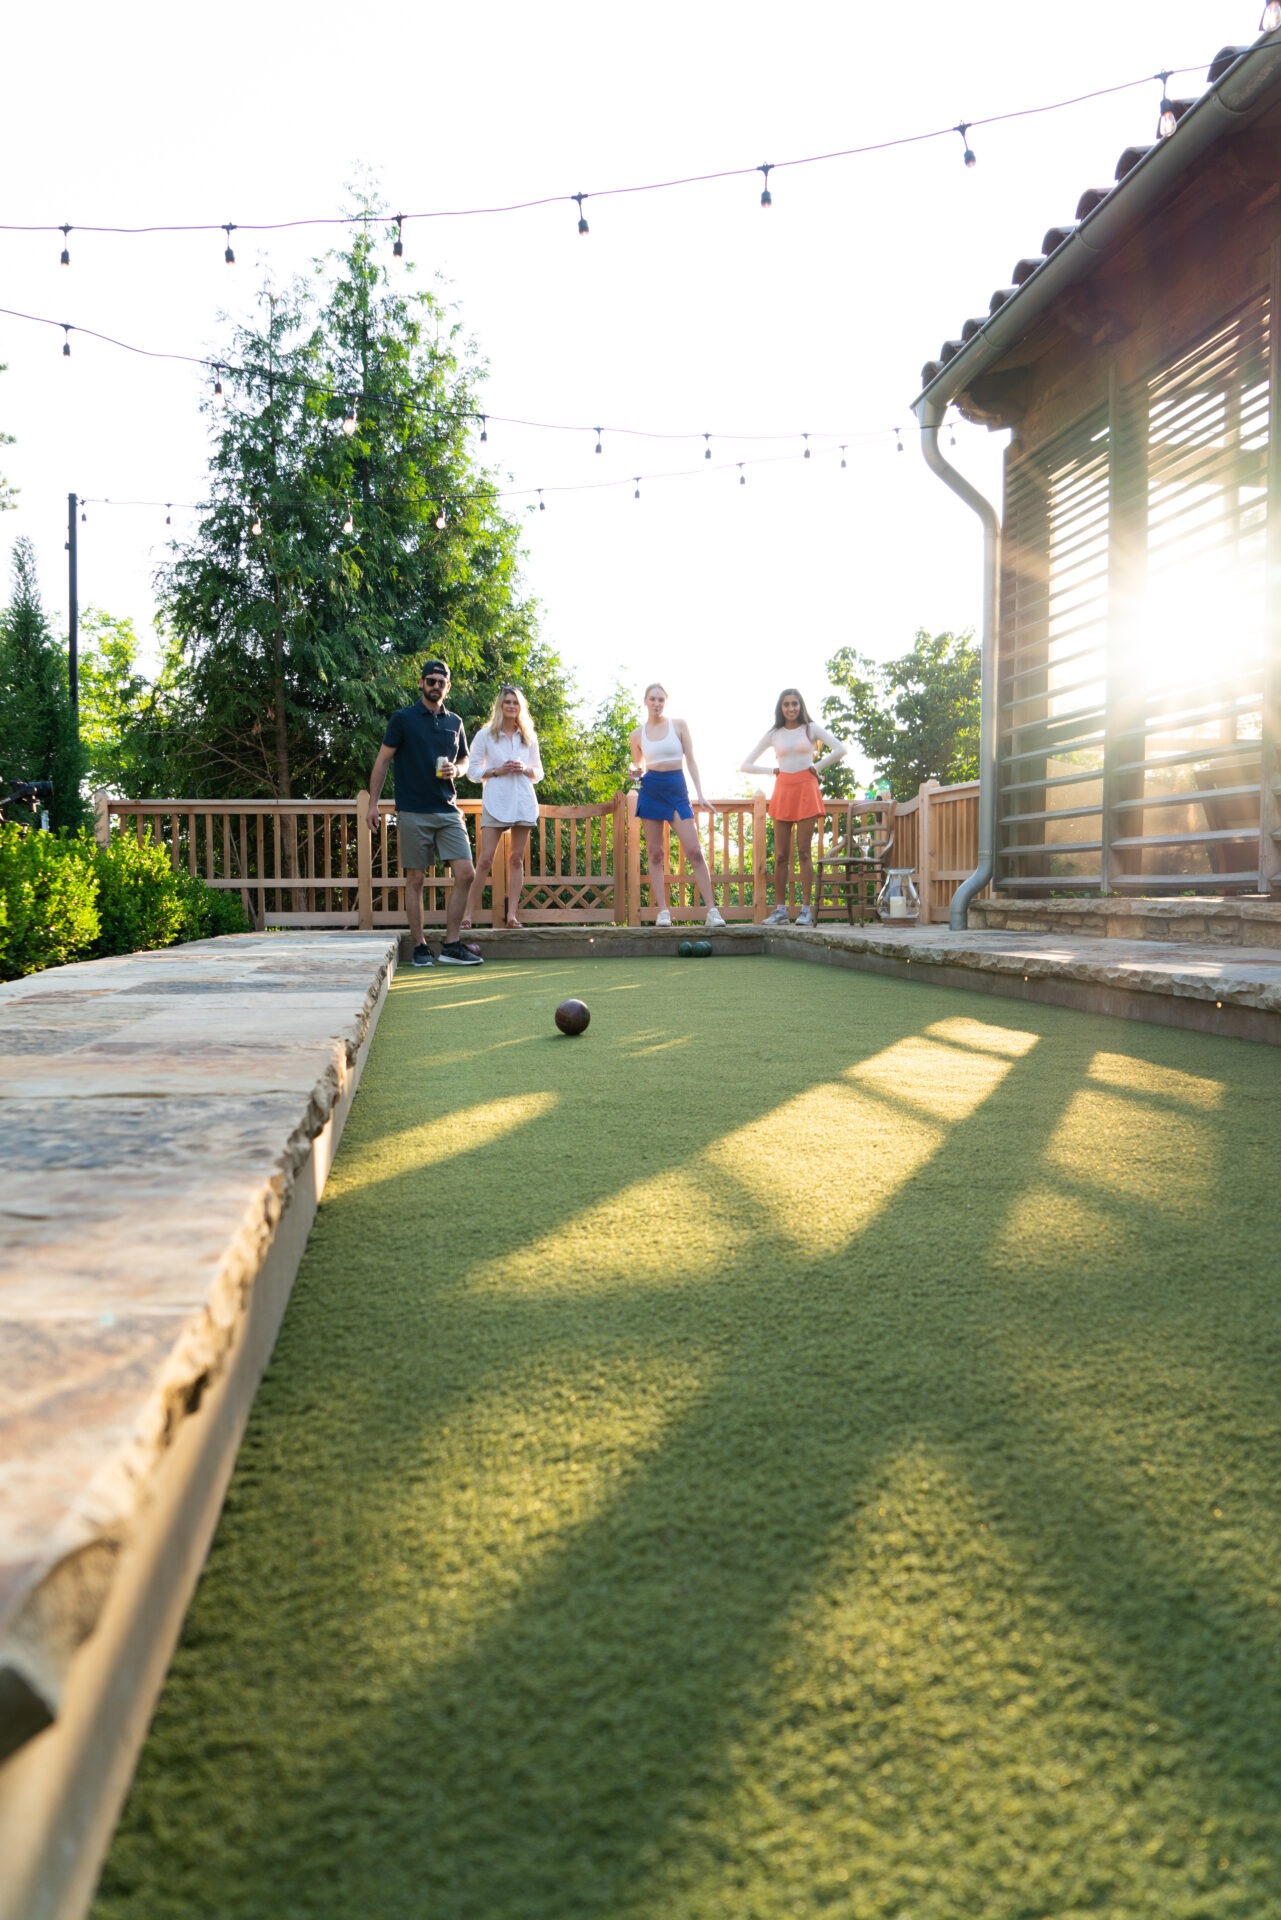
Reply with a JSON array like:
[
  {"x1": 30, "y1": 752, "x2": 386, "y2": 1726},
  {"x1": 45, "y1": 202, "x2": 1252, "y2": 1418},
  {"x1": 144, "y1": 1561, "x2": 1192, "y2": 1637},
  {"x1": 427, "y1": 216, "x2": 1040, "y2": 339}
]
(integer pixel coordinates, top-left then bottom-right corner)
[{"x1": 822, "y1": 628, "x2": 979, "y2": 797}]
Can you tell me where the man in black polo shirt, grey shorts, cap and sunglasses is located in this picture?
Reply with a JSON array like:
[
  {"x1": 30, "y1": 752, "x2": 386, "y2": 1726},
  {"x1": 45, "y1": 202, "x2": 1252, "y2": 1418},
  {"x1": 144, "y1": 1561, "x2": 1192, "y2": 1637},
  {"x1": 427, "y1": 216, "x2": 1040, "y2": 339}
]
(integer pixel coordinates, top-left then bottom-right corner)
[{"x1": 369, "y1": 660, "x2": 480, "y2": 966}]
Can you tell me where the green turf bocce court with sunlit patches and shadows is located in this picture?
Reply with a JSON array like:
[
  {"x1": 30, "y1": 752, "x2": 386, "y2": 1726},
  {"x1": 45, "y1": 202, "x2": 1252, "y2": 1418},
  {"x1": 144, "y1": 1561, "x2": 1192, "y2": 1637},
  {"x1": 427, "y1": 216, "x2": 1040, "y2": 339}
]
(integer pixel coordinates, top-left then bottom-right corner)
[{"x1": 94, "y1": 954, "x2": 1281, "y2": 1920}]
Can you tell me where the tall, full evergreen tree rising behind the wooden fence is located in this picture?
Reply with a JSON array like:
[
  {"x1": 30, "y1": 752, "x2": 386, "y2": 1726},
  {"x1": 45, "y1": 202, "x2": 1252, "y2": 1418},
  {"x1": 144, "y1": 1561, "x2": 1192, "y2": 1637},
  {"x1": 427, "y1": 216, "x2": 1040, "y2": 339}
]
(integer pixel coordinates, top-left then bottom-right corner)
[{"x1": 159, "y1": 207, "x2": 536, "y2": 797}]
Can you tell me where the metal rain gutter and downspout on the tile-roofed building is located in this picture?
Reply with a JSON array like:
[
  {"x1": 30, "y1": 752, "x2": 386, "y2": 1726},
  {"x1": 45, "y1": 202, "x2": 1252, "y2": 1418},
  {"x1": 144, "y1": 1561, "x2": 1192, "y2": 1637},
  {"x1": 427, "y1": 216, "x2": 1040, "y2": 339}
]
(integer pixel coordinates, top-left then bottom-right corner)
[{"x1": 912, "y1": 29, "x2": 1281, "y2": 931}]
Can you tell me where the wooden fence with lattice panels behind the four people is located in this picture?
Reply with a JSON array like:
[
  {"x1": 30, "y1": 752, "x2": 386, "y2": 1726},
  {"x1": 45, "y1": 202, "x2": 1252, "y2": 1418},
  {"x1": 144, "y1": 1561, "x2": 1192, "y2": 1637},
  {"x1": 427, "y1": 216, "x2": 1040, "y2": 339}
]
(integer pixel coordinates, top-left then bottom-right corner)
[{"x1": 94, "y1": 781, "x2": 978, "y2": 929}]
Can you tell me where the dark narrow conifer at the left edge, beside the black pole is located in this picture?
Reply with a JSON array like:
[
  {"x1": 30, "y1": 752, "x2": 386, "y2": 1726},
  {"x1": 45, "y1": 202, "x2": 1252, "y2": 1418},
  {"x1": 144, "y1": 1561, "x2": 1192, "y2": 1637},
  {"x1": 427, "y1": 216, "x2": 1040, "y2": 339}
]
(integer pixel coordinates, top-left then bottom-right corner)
[{"x1": 0, "y1": 540, "x2": 86, "y2": 828}]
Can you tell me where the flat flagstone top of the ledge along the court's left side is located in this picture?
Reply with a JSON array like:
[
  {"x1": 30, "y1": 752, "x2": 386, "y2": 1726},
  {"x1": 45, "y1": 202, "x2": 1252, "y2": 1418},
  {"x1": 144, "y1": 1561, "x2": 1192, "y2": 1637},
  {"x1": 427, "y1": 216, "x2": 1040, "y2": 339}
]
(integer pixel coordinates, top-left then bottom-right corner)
[{"x1": 0, "y1": 933, "x2": 396, "y2": 1789}]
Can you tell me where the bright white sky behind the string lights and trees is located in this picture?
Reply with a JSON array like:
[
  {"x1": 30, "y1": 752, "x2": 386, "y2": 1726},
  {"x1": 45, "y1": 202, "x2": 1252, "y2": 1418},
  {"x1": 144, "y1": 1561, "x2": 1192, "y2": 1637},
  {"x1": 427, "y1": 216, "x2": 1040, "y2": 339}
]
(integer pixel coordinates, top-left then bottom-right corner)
[{"x1": 0, "y1": 0, "x2": 1260, "y2": 795}]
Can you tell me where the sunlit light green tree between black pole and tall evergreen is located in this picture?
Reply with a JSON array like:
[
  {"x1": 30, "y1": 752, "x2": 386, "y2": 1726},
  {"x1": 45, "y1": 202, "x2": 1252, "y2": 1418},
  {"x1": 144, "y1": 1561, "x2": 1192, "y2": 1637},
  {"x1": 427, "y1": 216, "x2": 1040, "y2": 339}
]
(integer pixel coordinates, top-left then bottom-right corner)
[{"x1": 81, "y1": 607, "x2": 184, "y2": 799}]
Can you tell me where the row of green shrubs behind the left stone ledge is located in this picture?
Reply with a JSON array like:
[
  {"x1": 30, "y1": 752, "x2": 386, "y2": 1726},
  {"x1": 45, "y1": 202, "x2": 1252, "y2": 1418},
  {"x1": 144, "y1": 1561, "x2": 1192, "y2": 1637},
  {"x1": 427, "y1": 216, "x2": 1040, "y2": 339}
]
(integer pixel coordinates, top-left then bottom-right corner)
[{"x1": 0, "y1": 822, "x2": 248, "y2": 979}]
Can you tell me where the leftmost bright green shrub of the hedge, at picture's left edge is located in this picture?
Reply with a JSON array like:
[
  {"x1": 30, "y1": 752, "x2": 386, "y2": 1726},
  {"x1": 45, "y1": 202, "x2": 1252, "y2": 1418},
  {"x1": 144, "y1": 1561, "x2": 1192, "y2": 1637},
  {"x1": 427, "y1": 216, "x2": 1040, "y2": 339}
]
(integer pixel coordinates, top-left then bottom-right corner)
[{"x1": 0, "y1": 822, "x2": 100, "y2": 979}]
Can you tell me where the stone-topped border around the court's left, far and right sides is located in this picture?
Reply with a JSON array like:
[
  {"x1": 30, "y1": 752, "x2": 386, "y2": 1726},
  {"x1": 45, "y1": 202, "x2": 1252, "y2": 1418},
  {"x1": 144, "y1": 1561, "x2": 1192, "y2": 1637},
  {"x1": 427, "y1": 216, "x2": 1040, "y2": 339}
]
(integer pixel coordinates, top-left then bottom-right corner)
[{"x1": 0, "y1": 925, "x2": 1281, "y2": 1920}]
